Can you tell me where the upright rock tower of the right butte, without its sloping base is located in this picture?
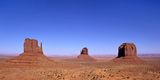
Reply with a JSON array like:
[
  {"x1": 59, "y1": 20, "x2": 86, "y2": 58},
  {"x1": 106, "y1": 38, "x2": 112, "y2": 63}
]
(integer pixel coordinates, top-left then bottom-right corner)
[{"x1": 117, "y1": 43, "x2": 137, "y2": 58}]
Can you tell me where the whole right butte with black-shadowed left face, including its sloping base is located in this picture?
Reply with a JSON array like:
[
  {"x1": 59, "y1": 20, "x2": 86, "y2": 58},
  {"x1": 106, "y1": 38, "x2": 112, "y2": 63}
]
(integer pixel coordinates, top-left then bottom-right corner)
[{"x1": 114, "y1": 43, "x2": 141, "y2": 62}]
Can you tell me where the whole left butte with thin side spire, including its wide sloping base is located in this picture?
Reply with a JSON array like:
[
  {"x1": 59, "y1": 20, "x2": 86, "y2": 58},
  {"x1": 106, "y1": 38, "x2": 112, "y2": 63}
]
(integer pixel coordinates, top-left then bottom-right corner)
[{"x1": 8, "y1": 38, "x2": 51, "y2": 65}]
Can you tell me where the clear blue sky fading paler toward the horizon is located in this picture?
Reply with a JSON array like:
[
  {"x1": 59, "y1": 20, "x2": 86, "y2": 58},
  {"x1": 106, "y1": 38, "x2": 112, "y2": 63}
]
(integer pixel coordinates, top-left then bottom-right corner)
[{"x1": 0, "y1": 0, "x2": 160, "y2": 55}]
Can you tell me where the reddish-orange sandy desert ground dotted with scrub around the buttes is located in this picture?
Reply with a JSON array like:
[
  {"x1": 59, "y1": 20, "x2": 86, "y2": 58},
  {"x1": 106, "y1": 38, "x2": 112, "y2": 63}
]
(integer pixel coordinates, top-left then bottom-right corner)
[{"x1": 0, "y1": 56, "x2": 160, "y2": 80}]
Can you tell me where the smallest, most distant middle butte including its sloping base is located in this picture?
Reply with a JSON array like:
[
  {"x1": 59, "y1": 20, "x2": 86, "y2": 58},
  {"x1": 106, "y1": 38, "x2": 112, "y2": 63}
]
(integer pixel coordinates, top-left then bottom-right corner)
[{"x1": 77, "y1": 47, "x2": 96, "y2": 61}]
